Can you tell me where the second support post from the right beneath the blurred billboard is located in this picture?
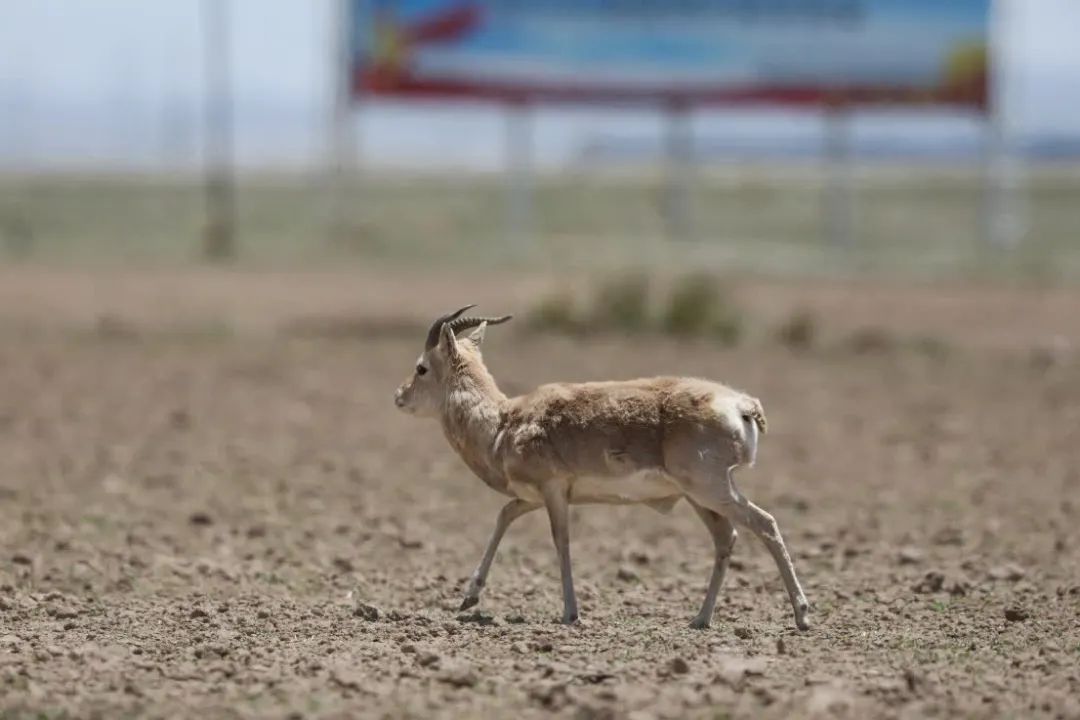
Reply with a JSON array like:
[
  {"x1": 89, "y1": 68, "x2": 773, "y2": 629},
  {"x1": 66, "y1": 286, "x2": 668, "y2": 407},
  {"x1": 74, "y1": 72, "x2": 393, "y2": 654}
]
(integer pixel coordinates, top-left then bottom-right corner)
[{"x1": 825, "y1": 105, "x2": 855, "y2": 250}]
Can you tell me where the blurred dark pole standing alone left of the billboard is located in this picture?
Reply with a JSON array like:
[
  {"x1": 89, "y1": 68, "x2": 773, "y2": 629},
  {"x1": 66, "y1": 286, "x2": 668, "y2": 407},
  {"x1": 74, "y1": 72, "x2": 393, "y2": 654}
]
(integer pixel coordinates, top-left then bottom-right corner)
[{"x1": 202, "y1": 0, "x2": 237, "y2": 260}]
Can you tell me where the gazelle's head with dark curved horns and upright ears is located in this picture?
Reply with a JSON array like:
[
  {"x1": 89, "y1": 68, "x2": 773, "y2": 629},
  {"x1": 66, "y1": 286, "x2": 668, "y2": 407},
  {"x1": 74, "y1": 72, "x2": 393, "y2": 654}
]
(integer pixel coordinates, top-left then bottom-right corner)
[{"x1": 394, "y1": 305, "x2": 512, "y2": 418}]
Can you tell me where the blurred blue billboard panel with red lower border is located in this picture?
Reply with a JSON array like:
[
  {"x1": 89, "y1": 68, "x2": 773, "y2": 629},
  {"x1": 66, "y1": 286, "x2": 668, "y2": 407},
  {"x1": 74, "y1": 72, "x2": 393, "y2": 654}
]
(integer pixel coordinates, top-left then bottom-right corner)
[{"x1": 349, "y1": 0, "x2": 991, "y2": 108}]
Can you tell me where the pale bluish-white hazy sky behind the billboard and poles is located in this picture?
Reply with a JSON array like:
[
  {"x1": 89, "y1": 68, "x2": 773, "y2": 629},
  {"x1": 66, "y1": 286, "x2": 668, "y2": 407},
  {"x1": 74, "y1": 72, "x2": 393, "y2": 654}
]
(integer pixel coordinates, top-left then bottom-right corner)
[{"x1": 0, "y1": 0, "x2": 1080, "y2": 170}]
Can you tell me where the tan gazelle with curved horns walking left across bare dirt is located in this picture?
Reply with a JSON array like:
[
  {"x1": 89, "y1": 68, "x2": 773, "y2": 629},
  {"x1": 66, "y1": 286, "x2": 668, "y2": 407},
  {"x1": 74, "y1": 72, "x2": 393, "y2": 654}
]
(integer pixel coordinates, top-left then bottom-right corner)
[{"x1": 394, "y1": 305, "x2": 809, "y2": 630}]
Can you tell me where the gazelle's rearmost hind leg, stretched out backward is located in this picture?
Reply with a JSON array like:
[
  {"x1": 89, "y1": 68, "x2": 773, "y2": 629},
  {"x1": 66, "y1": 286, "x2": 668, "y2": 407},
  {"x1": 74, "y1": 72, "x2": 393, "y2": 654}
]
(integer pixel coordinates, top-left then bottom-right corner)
[{"x1": 686, "y1": 467, "x2": 810, "y2": 630}]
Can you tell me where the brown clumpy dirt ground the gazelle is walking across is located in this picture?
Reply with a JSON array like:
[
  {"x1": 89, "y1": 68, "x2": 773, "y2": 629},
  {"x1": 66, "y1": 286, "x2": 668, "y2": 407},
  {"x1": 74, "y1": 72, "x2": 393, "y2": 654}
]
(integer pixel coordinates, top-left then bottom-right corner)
[{"x1": 0, "y1": 270, "x2": 1080, "y2": 718}]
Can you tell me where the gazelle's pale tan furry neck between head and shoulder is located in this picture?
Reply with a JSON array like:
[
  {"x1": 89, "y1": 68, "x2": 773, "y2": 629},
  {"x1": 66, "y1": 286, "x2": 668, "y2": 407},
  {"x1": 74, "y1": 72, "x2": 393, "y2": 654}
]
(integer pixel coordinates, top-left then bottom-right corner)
[{"x1": 441, "y1": 358, "x2": 507, "y2": 484}]
